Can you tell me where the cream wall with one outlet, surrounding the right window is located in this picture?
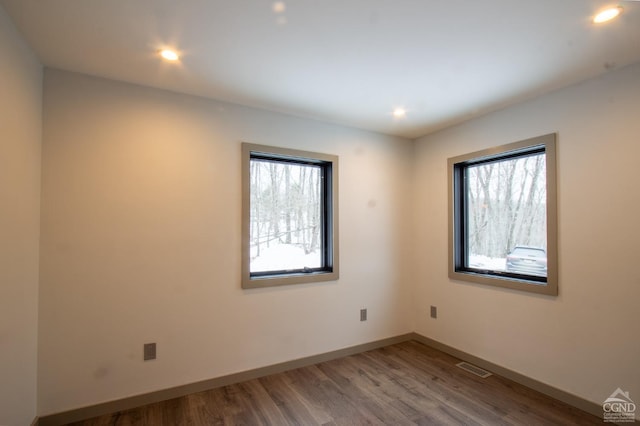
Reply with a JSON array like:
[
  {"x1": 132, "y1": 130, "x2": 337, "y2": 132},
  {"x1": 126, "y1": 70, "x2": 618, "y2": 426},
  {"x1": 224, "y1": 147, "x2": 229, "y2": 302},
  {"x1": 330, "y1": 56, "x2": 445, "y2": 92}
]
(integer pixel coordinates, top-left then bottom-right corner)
[{"x1": 414, "y1": 60, "x2": 640, "y2": 404}]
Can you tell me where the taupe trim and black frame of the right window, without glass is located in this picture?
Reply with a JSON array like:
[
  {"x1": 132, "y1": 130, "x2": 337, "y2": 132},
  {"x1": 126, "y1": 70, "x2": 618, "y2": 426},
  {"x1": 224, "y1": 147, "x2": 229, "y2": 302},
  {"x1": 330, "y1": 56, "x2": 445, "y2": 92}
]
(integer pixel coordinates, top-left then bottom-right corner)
[{"x1": 447, "y1": 133, "x2": 558, "y2": 296}]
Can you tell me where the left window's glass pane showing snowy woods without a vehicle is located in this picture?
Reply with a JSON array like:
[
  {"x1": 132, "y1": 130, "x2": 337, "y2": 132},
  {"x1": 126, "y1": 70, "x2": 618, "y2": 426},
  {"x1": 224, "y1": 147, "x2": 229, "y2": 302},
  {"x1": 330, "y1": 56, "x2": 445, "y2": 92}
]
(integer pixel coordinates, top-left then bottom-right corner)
[{"x1": 249, "y1": 158, "x2": 324, "y2": 273}]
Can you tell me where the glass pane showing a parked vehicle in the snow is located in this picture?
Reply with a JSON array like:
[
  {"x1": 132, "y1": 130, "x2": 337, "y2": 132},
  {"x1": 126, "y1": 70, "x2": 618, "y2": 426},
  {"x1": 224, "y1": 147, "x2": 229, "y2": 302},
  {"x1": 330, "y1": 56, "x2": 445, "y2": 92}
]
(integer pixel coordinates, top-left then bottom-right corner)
[{"x1": 465, "y1": 152, "x2": 547, "y2": 277}]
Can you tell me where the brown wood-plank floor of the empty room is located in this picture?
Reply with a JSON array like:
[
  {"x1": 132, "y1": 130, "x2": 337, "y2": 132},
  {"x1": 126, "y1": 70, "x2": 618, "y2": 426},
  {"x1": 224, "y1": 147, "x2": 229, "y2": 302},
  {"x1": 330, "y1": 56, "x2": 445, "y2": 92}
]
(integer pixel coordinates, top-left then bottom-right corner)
[{"x1": 67, "y1": 341, "x2": 603, "y2": 426}]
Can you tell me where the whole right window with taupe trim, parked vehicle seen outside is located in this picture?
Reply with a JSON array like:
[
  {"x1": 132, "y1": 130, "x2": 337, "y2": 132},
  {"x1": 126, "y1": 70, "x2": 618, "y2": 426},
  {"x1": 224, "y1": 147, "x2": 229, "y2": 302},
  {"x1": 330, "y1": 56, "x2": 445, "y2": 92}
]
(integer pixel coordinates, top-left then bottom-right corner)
[{"x1": 448, "y1": 134, "x2": 558, "y2": 295}]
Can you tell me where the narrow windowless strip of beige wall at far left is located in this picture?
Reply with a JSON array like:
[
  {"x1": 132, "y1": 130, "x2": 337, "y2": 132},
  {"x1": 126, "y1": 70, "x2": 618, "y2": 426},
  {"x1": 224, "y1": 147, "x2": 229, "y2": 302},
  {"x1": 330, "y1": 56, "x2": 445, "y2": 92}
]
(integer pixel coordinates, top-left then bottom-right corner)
[{"x1": 0, "y1": 6, "x2": 42, "y2": 425}]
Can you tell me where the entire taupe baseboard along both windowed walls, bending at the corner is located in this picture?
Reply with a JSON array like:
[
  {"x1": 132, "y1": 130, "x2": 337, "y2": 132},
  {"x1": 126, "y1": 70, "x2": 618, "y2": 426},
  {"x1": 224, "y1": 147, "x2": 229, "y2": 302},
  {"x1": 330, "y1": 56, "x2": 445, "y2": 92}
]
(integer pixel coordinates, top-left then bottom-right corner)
[{"x1": 38, "y1": 333, "x2": 602, "y2": 426}]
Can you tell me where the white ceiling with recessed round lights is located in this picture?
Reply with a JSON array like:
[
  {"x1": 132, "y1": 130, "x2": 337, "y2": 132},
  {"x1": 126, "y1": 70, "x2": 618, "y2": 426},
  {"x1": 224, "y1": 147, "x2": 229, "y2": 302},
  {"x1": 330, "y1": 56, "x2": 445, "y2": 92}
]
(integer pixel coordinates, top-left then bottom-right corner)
[{"x1": 0, "y1": 0, "x2": 640, "y2": 138}]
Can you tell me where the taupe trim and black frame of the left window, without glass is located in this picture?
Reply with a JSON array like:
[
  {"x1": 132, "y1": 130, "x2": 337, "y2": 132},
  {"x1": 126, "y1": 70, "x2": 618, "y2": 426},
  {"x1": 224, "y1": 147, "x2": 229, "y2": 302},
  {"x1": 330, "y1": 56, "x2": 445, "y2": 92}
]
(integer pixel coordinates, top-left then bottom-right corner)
[{"x1": 241, "y1": 142, "x2": 339, "y2": 289}]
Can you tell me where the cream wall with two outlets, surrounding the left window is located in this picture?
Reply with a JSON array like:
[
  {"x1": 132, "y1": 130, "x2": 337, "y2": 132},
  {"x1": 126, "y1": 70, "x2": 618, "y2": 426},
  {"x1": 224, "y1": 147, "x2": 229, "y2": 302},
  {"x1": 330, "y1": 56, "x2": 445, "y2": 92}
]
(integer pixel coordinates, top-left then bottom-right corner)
[{"x1": 39, "y1": 69, "x2": 412, "y2": 415}]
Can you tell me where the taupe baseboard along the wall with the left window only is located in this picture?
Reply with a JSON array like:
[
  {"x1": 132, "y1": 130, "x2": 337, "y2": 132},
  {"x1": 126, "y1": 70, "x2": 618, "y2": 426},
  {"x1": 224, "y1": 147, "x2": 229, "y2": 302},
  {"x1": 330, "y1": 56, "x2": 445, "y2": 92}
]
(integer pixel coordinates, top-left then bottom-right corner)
[{"x1": 37, "y1": 333, "x2": 414, "y2": 426}]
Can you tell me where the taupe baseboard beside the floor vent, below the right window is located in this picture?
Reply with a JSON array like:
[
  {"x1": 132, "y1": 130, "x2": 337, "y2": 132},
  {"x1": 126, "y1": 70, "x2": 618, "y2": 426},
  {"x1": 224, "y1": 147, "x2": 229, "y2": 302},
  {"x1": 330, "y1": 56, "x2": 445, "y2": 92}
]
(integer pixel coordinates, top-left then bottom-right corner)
[{"x1": 413, "y1": 333, "x2": 602, "y2": 418}]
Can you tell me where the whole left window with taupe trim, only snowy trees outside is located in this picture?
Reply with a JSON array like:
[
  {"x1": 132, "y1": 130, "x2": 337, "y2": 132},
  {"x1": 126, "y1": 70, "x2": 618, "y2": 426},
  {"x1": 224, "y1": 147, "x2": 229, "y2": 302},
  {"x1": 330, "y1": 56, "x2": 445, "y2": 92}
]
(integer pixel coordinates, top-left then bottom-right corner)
[{"x1": 242, "y1": 143, "x2": 338, "y2": 288}]
